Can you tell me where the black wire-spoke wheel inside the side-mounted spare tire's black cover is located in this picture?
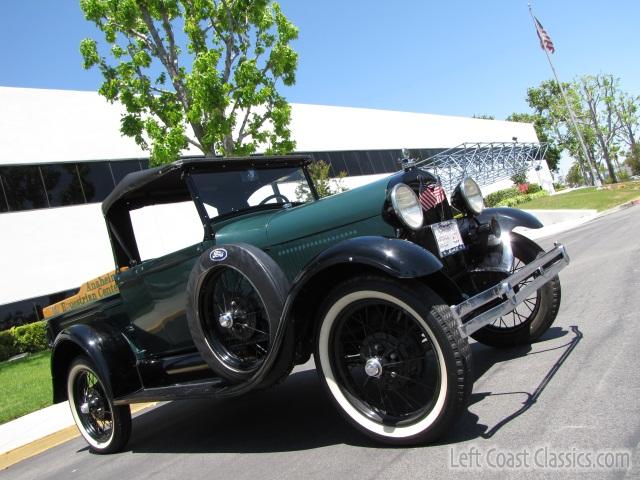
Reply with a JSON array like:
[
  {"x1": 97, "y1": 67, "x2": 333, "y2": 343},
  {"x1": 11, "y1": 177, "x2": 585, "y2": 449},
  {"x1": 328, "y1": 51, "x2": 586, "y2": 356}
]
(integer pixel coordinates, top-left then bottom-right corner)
[{"x1": 200, "y1": 268, "x2": 271, "y2": 372}]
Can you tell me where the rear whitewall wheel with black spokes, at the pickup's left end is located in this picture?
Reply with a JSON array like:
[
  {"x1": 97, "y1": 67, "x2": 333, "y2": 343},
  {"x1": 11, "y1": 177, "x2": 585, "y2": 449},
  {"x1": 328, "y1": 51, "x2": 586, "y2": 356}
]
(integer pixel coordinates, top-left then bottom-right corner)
[{"x1": 67, "y1": 357, "x2": 131, "y2": 453}]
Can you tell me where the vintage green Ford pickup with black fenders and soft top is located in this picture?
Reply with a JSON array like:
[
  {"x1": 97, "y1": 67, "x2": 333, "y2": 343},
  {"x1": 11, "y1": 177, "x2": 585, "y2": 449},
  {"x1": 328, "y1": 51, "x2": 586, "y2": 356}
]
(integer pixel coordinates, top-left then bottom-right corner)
[{"x1": 48, "y1": 156, "x2": 569, "y2": 453}]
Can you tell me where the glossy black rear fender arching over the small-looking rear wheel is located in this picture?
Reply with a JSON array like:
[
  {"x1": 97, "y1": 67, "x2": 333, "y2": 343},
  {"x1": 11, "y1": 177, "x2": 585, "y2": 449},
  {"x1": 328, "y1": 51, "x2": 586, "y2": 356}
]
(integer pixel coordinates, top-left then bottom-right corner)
[{"x1": 51, "y1": 324, "x2": 142, "y2": 402}]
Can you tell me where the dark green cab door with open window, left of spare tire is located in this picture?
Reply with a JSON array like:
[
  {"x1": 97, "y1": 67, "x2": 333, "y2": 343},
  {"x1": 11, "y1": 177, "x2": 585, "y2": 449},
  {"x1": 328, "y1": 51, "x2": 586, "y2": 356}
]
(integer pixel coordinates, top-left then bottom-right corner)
[{"x1": 119, "y1": 201, "x2": 213, "y2": 357}]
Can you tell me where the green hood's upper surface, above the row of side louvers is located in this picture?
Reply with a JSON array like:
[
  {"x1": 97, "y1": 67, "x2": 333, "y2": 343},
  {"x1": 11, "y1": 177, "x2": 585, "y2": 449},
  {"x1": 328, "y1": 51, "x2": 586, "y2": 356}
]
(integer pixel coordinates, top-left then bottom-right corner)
[{"x1": 216, "y1": 173, "x2": 390, "y2": 249}]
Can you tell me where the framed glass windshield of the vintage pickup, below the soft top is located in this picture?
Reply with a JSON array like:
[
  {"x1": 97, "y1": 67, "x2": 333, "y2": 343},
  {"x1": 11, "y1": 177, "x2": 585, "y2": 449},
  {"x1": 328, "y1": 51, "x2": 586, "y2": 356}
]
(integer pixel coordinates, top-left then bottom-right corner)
[{"x1": 192, "y1": 167, "x2": 311, "y2": 219}]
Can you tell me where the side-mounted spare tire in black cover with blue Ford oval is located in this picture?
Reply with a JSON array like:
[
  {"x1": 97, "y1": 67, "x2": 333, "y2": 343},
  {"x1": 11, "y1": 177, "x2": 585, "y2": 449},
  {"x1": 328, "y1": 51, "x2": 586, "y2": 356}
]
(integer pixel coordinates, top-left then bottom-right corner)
[{"x1": 186, "y1": 243, "x2": 289, "y2": 383}]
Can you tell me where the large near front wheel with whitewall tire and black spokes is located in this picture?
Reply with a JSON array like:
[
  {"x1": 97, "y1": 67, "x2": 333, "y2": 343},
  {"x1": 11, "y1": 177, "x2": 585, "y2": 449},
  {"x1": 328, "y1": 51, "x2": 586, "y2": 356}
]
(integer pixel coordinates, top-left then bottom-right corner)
[{"x1": 315, "y1": 277, "x2": 473, "y2": 445}]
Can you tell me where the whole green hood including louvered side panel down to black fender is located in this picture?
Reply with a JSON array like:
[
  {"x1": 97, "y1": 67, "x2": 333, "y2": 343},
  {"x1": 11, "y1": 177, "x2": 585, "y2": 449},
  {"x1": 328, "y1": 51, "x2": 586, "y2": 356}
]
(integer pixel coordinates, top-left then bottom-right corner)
[{"x1": 214, "y1": 173, "x2": 394, "y2": 280}]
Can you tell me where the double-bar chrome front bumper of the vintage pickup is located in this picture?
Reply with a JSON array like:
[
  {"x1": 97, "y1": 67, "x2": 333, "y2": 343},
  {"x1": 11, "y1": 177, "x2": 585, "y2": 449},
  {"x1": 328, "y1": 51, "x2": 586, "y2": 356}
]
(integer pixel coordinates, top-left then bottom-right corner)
[{"x1": 451, "y1": 244, "x2": 570, "y2": 338}]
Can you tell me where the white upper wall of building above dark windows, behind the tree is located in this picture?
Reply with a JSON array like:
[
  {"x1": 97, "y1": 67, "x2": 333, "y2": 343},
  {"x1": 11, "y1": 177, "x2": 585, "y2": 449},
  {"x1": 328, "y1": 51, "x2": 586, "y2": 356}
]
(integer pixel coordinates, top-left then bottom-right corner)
[{"x1": 0, "y1": 87, "x2": 538, "y2": 165}]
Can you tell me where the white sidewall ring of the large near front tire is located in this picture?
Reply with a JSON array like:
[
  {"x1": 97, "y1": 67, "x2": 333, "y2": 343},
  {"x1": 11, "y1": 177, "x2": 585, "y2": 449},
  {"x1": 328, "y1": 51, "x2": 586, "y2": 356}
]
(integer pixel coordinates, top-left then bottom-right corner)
[{"x1": 318, "y1": 290, "x2": 448, "y2": 439}]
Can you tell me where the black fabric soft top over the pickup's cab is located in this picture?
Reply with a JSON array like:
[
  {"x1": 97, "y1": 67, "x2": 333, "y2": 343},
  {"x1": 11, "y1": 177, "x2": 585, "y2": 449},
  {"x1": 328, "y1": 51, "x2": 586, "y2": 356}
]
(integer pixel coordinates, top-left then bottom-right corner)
[{"x1": 102, "y1": 155, "x2": 311, "y2": 216}]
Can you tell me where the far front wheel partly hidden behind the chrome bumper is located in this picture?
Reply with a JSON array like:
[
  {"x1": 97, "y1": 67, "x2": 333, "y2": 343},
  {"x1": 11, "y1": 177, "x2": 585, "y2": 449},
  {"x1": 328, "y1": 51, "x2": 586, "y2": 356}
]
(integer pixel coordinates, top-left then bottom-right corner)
[{"x1": 472, "y1": 233, "x2": 561, "y2": 347}]
